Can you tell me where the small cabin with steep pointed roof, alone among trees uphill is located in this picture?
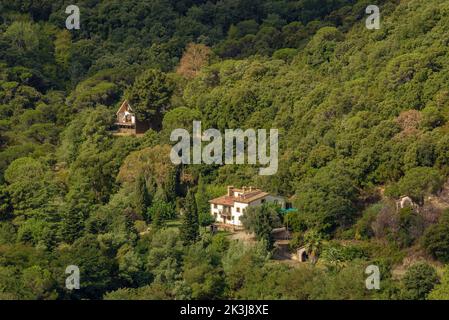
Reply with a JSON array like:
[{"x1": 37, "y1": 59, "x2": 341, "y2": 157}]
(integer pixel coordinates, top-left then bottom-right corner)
[{"x1": 115, "y1": 100, "x2": 150, "y2": 135}]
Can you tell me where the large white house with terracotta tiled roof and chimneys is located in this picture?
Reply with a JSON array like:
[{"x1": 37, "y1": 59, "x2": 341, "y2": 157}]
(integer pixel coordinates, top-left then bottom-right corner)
[{"x1": 209, "y1": 186, "x2": 285, "y2": 226}]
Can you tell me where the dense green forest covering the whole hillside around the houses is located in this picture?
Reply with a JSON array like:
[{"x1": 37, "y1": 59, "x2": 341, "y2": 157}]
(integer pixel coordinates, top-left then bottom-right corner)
[{"x1": 0, "y1": 0, "x2": 449, "y2": 299}]
